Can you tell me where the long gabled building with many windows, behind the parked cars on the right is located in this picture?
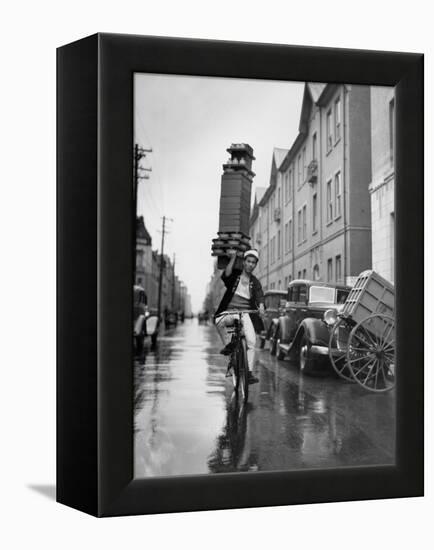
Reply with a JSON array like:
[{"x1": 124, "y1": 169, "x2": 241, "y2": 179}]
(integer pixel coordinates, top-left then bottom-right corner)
[{"x1": 250, "y1": 83, "x2": 372, "y2": 289}]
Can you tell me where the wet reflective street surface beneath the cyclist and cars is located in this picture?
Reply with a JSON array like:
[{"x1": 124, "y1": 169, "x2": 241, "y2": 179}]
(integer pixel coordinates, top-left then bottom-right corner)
[{"x1": 134, "y1": 319, "x2": 395, "y2": 478}]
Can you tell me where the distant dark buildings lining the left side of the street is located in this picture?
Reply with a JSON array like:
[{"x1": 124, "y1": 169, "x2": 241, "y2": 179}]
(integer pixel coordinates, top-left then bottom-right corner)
[{"x1": 135, "y1": 216, "x2": 191, "y2": 317}]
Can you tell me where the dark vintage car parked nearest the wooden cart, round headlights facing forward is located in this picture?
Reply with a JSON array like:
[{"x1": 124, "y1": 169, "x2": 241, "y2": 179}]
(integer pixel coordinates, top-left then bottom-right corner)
[{"x1": 274, "y1": 279, "x2": 351, "y2": 373}]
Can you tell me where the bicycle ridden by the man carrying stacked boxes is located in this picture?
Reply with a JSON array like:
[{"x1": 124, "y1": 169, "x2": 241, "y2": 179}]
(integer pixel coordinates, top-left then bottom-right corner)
[{"x1": 219, "y1": 309, "x2": 259, "y2": 403}]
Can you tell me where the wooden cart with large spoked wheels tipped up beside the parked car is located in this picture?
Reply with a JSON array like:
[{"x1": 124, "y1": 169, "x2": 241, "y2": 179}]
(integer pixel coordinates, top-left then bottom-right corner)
[{"x1": 329, "y1": 270, "x2": 395, "y2": 392}]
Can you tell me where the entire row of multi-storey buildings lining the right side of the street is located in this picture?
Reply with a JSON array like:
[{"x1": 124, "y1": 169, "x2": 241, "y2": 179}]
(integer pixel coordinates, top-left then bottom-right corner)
[{"x1": 203, "y1": 83, "x2": 395, "y2": 308}]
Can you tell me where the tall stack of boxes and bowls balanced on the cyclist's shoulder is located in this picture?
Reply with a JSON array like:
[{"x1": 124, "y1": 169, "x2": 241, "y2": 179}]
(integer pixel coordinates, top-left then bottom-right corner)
[{"x1": 212, "y1": 143, "x2": 255, "y2": 269}]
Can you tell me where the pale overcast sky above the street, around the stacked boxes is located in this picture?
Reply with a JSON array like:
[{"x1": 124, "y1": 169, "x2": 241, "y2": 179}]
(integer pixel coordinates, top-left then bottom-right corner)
[{"x1": 134, "y1": 73, "x2": 304, "y2": 312}]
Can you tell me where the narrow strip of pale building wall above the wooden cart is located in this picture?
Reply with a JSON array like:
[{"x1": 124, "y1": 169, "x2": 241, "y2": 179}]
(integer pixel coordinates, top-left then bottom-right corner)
[{"x1": 369, "y1": 86, "x2": 395, "y2": 283}]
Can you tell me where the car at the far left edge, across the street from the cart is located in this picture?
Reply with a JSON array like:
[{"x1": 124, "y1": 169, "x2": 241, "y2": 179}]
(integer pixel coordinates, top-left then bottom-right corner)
[{"x1": 133, "y1": 285, "x2": 160, "y2": 354}]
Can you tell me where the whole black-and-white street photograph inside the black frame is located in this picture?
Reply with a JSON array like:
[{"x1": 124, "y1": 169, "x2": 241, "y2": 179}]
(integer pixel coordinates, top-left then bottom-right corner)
[{"x1": 132, "y1": 73, "x2": 396, "y2": 478}]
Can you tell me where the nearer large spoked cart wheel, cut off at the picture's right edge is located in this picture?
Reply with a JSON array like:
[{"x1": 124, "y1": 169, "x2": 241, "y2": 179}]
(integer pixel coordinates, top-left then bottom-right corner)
[{"x1": 347, "y1": 313, "x2": 395, "y2": 392}]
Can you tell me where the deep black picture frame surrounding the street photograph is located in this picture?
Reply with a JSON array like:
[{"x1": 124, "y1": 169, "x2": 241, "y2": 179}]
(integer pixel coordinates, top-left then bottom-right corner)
[{"x1": 57, "y1": 34, "x2": 424, "y2": 516}]
